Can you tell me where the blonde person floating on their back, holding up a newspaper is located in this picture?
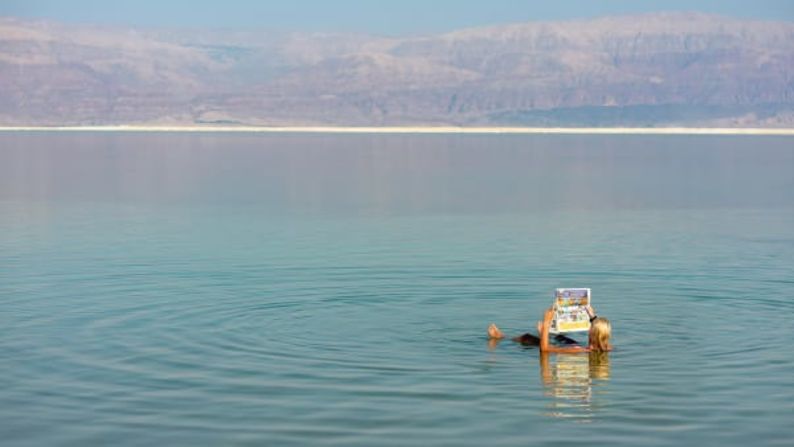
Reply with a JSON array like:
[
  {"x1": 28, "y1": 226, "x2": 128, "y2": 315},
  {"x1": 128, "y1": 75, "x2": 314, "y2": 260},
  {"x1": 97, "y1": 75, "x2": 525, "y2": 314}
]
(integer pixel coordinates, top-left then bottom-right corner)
[{"x1": 488, "y1": 306, "x2": 612, "y2": 353}]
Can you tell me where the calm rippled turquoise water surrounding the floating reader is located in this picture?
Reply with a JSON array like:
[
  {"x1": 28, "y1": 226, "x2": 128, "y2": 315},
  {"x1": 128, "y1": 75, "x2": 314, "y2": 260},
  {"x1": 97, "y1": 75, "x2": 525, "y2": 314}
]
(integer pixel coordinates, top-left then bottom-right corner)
[{"x1": 0, "y1": 133, "x2": 794, "y2": 446}]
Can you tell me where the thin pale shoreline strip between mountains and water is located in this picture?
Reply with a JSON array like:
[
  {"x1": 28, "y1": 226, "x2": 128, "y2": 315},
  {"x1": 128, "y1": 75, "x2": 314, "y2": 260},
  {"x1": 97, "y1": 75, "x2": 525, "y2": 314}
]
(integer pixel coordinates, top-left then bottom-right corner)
[{"x1": 0, "y1": 125, "x2": 794, "y2": 136}]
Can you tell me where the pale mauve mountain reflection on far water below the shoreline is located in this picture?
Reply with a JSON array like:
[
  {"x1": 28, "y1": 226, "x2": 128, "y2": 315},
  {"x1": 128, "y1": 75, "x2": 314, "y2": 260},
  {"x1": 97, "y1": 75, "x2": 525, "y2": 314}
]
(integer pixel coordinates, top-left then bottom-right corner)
[{"x1": 0, "y1": 133, "x2": 794, "y2": 216}]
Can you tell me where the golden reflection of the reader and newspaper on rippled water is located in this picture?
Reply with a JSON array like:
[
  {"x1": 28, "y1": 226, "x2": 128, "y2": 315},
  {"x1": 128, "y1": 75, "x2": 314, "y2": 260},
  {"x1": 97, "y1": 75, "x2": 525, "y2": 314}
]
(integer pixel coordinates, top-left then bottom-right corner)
[{"x1": 539, "y1": 352, "x2": 609, "y2": 422}]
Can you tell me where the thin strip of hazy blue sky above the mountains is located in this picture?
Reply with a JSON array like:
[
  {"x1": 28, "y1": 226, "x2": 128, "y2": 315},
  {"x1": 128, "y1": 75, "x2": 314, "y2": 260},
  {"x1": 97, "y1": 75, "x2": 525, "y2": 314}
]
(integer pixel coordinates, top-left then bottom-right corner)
[{"x1": 0, "y1": 0, "x2": 794, "y2": 35}]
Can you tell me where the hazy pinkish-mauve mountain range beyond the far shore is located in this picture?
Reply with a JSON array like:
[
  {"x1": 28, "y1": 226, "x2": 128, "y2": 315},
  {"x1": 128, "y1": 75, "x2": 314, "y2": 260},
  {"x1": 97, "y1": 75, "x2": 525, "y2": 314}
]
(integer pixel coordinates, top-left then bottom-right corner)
[{"x1": 0, "y1": 13, "x2": 794, "y2": 127}]
